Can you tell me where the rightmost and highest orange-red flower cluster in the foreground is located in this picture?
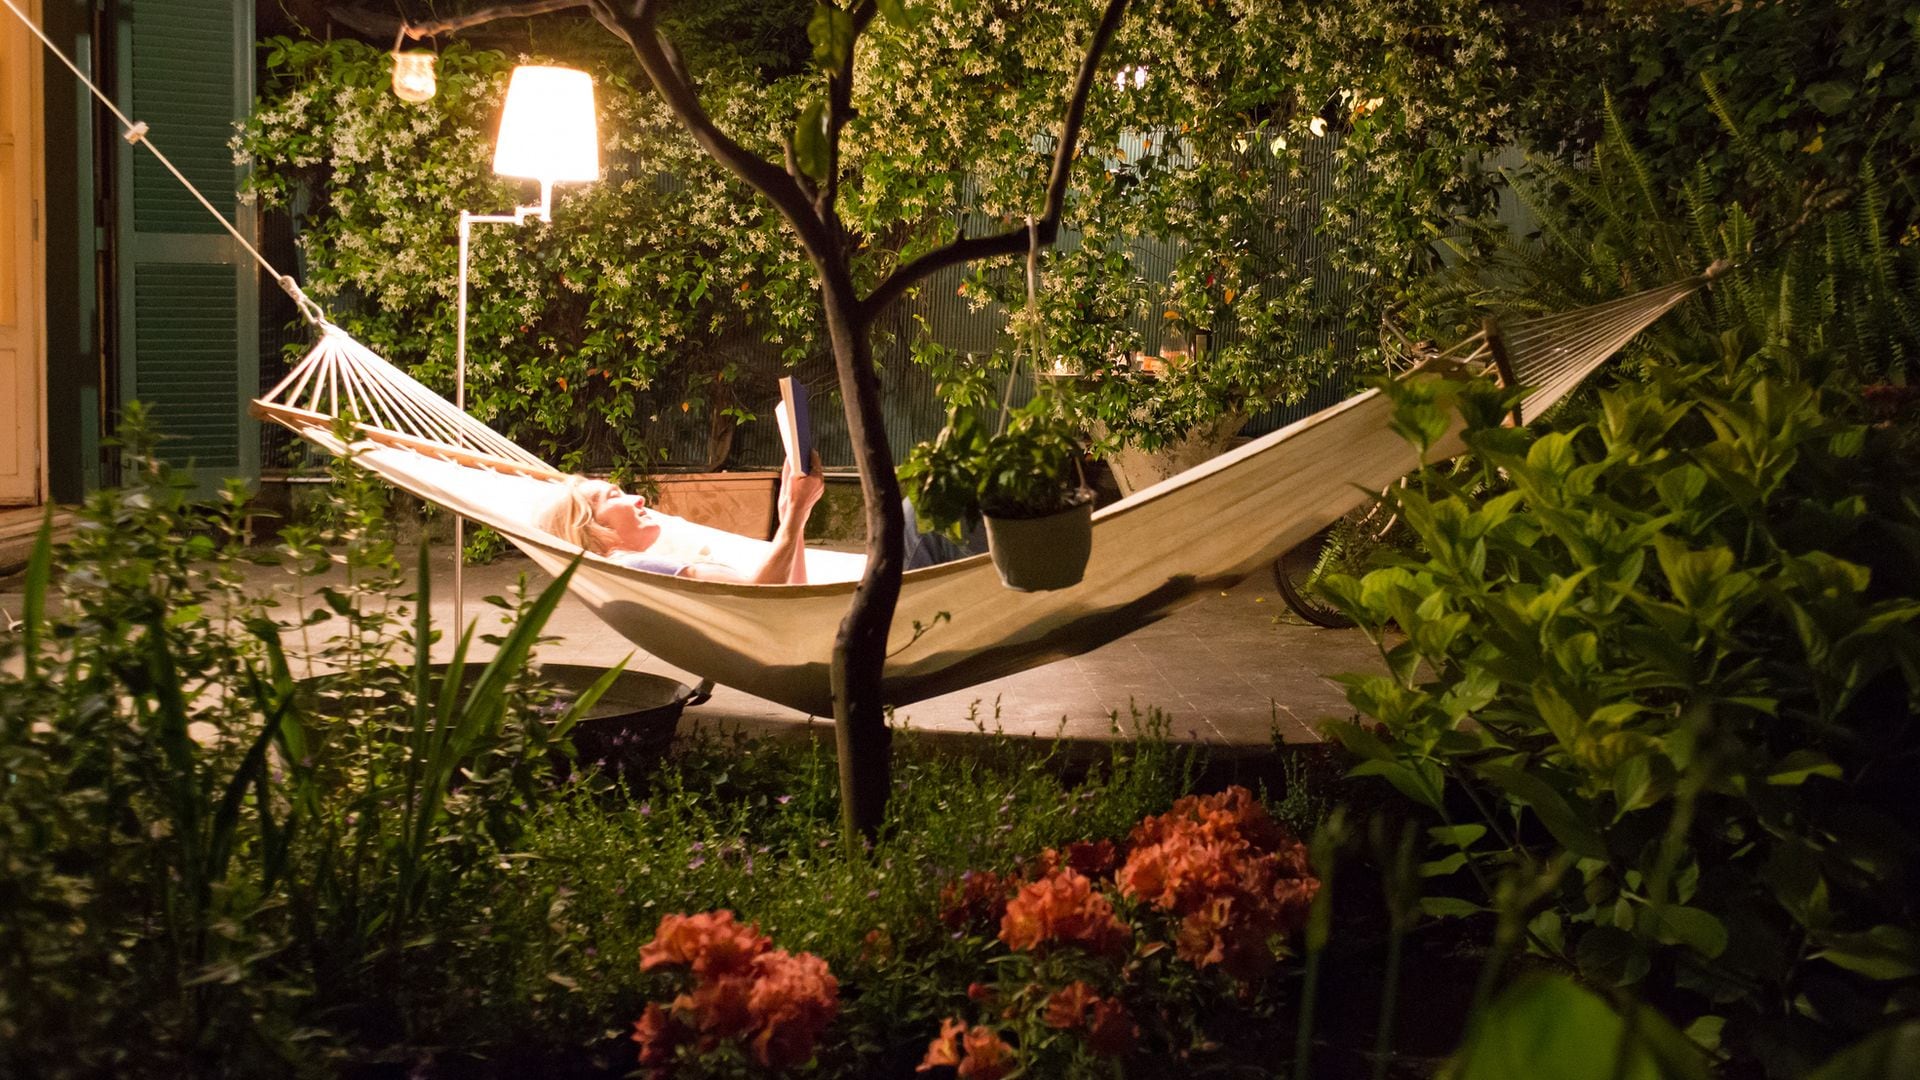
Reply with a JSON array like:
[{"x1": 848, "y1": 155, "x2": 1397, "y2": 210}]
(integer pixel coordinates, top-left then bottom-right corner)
[{"x1": 1116, "y1": 786, "x2": 1319, "y2": 980}]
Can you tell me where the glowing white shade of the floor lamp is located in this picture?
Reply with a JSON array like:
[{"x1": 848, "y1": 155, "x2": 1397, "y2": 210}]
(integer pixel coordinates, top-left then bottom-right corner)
[{"x1": 493, "y1": 65, "x2": 599, "y2": 183}]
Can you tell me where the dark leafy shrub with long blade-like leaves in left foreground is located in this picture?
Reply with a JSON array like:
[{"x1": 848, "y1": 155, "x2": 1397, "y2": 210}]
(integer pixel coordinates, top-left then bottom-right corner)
[{"x1": 0, "y1": 407, "x2": 593, "y2": 1076}]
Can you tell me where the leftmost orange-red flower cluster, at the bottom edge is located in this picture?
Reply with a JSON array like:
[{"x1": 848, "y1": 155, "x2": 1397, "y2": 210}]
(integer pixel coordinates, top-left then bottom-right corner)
[{"x1": 634, "y1": 911, "x2": 839, "y2": 1070}]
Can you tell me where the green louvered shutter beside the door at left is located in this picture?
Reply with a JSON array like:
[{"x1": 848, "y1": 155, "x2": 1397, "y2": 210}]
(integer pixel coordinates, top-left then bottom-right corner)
[{"x1": 117, "y1": 0, "x2": 259, "y2": 490}]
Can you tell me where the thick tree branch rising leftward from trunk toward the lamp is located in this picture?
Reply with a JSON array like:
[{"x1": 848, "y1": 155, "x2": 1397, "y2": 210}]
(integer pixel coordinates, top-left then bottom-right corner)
[{"x1": 589, "y1": 0, "x2": 833, "y2": 255}]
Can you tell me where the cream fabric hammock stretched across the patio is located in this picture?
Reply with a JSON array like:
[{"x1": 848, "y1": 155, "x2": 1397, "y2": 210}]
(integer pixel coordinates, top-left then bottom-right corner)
[{"x1": 255, "y1": 279, "x2": 1705, "y2": 715}]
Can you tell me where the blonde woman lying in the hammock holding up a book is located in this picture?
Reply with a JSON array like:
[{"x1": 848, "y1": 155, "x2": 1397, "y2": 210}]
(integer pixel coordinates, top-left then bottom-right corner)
[{"x1": 534, "y1": 454, "x2": 826, "y2": 584}]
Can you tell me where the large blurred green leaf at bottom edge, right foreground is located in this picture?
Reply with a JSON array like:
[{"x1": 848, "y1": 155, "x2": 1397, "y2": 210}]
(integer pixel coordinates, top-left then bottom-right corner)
[{"x1": 1448, "y1": 974, "x2": 1707, "y2": 1080}]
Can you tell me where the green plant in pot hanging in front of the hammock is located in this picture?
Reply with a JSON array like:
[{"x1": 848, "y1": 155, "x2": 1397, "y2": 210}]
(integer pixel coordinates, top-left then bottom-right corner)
[{"x1": 900, "y1": 373, "x2": 1092, "y2": 592}]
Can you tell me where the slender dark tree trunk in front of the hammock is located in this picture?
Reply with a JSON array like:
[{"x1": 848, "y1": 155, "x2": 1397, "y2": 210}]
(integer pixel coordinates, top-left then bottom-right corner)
[{"x1": 820, "y1": 261, "x2": 906, "y2": 842}]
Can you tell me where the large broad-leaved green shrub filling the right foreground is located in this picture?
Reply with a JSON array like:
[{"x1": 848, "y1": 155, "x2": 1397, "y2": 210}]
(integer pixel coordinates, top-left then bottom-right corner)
[{"x1": 1327, "y1": 334, "x2": 1920, "y2": 1074}]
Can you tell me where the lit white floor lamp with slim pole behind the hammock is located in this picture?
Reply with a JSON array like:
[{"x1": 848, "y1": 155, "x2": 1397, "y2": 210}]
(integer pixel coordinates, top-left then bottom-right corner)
[{"x1": 453, "y1": 65, "x2": 599, "y2": 634}]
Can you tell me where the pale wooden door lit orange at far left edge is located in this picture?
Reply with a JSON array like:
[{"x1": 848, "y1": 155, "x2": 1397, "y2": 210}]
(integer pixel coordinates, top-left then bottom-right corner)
[{"x1": 0, "y1": 0, "x2": 48, "y2": 505}]
